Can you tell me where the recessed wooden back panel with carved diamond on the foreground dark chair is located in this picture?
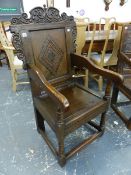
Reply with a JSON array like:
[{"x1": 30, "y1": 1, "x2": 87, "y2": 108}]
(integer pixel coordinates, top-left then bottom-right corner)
[{"x1": 23, "y1": 28, "x2": 70, "y2": 80}]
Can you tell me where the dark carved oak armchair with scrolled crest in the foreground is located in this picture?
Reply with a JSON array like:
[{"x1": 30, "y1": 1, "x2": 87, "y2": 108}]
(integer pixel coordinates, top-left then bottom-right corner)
[{"x1": 11, "y1": 7, "x2": 122, "y2": 166}]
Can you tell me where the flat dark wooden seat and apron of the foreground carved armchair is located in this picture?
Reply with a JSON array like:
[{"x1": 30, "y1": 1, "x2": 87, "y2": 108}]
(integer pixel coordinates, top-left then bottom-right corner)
[{"x1": 34, "y1": 86, "x2": 108, "y2": 135}]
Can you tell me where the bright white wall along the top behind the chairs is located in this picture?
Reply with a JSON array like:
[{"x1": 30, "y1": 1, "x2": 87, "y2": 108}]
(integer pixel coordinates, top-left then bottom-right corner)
[{"x1": 23, "y1": 0, "x2": 131, "y2": 22}]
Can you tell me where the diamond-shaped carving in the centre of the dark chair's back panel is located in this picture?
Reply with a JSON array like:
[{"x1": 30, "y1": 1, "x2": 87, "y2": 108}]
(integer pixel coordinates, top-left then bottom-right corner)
[{"x1": 39, "y1": 35, "x2": 64, "y2": 75}]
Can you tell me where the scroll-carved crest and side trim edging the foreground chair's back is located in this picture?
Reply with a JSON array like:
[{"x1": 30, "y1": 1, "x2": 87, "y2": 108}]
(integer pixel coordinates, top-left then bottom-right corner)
[{"x1": 11, "y1": 6, "x2": 76, "y2": 66}]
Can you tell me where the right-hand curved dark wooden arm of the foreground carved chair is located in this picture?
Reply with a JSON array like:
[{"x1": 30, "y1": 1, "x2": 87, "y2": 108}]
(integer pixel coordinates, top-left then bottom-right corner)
[{"x1": 71, "y1": 54, "x2": 124, "y2": 83}]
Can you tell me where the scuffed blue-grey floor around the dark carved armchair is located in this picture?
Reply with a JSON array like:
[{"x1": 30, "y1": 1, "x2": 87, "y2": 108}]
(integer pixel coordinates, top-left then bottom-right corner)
[{"x1": 0, "y1": 63, "x2": 131, "y2": 175}]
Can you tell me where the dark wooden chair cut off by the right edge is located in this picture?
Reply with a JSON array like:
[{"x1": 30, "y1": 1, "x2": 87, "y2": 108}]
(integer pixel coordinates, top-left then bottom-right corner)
[{"x1": 111, "y1": 24, "x2": 131, "y2": 130}]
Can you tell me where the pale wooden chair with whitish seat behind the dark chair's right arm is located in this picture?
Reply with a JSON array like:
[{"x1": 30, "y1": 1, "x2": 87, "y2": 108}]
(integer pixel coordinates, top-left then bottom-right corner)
[{"x1": 88, "y1": 26, "x2": 122, "y2": 91}]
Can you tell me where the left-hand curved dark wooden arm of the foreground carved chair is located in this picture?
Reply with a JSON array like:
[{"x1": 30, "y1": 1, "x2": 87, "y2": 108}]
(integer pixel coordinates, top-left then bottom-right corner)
[{"x1": 29, "y1": 66, "x2": 69, "y2": 110}]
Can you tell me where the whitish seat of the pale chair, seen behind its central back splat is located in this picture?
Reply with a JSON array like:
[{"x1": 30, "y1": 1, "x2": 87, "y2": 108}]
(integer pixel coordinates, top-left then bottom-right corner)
[{"x1": 91, "y1": 53, "x2": 111, "y2": 65}]
